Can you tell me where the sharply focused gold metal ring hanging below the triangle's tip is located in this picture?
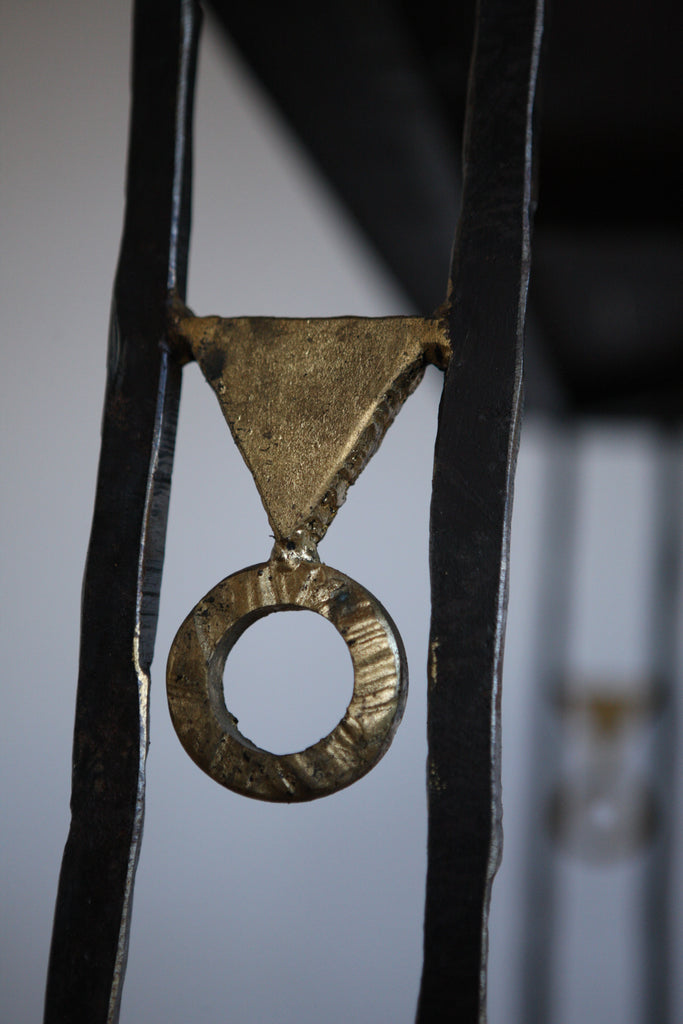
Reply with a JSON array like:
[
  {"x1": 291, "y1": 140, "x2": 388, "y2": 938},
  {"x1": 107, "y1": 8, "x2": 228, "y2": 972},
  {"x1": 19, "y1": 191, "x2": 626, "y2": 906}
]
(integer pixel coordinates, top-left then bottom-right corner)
[{"x1": 167, "y1": 545, "x2": 408, "y2": 802}]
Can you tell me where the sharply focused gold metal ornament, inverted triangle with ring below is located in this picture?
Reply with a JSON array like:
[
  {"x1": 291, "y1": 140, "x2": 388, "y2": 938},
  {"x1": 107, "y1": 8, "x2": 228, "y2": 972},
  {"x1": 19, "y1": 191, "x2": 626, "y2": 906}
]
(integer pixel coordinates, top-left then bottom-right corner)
[{"x1": 167, "y1": 316, "x2": 450, "y2": 802}]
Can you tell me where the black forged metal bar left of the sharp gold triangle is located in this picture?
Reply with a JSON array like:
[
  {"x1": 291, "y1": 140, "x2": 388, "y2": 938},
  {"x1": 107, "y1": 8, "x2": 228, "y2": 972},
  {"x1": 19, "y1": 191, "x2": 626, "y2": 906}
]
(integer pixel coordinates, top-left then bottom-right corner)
[{"x1": 45, "y1": 0, "x2": 200, "y2": 1024}]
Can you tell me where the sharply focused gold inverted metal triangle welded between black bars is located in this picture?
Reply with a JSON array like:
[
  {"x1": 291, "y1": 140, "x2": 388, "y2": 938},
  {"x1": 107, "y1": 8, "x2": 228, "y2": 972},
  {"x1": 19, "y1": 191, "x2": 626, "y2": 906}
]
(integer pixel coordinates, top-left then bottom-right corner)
[{"x1": 179, "y1": 316, "x2": 450, "y2": 542}]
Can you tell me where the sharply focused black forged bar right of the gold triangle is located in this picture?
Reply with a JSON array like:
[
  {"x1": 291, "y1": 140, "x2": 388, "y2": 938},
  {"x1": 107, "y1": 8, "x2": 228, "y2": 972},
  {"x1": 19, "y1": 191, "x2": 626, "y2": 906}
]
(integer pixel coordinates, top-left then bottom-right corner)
[{"x1": 418, "y1": 0, "x2": 543, "y2": 1024}]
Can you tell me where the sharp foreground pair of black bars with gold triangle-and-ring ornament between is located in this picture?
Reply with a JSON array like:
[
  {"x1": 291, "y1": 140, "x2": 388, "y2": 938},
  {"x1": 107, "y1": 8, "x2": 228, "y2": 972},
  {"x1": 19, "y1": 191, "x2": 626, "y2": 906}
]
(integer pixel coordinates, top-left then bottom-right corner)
[{"x1": 44, "y1": 0, "x2": 543, "y2": 1011}]
